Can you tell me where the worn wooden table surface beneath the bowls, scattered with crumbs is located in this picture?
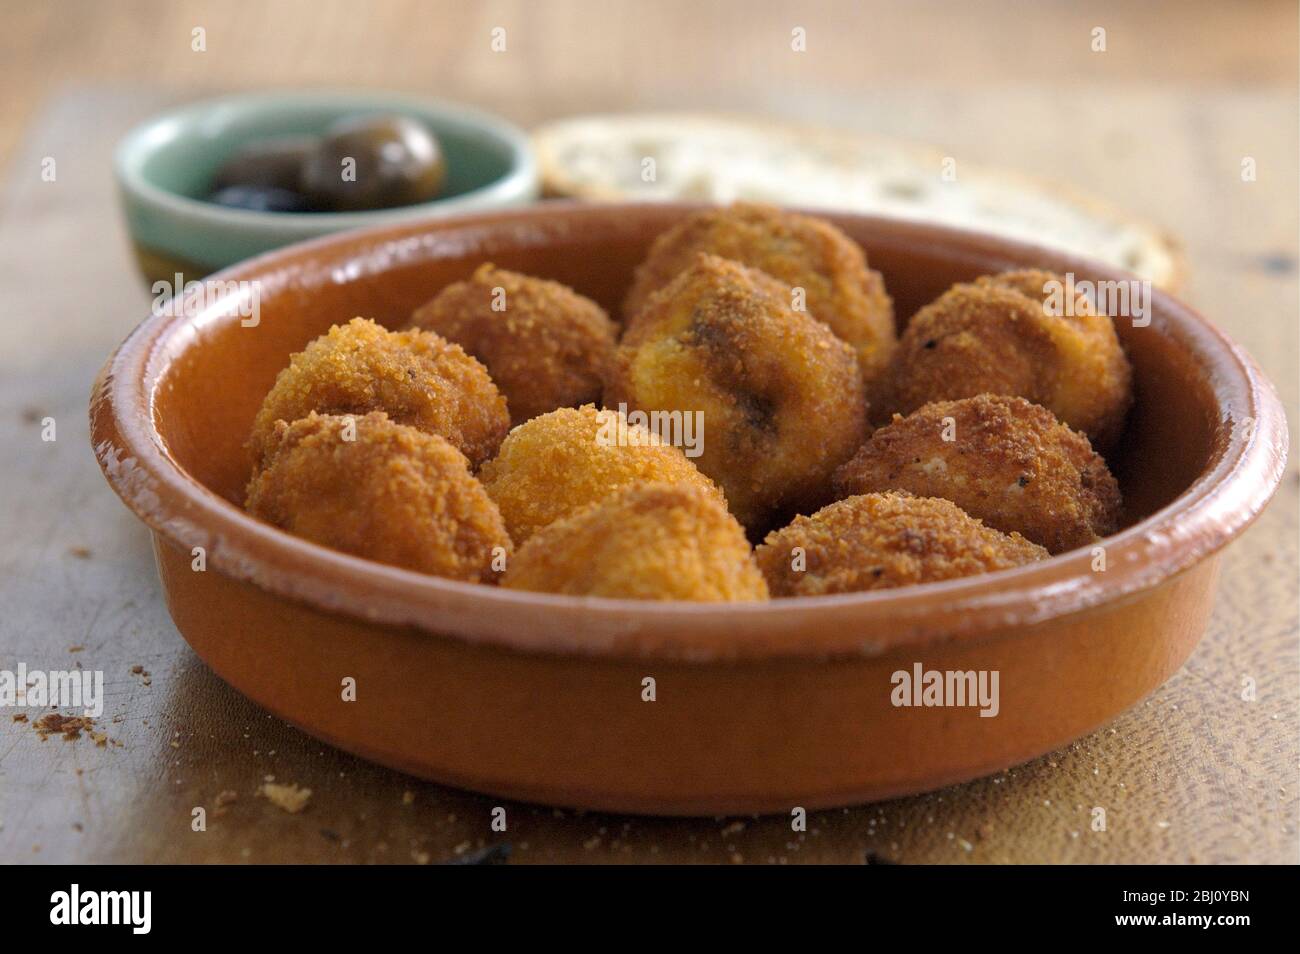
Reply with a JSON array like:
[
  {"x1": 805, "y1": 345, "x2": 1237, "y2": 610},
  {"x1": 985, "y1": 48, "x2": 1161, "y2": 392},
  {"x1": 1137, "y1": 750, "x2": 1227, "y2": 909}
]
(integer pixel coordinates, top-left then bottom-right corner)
[{"x1": 0, "y1": 3, "x2": 1300, "y2": 863}]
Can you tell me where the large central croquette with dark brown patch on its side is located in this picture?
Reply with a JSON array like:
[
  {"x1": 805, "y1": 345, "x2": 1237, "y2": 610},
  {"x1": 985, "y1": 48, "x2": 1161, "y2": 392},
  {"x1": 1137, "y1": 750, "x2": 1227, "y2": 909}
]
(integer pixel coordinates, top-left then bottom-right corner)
[{"x1": 605, "y1": 255, "x2": 866, "y2": 530}]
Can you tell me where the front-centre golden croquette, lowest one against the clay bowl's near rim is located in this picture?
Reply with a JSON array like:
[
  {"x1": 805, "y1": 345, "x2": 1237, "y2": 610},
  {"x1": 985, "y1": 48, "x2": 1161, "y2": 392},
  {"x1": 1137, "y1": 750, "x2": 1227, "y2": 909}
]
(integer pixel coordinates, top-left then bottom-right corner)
[{"x1": 502, "y1": 483, "x2": 767, "y2": 602}]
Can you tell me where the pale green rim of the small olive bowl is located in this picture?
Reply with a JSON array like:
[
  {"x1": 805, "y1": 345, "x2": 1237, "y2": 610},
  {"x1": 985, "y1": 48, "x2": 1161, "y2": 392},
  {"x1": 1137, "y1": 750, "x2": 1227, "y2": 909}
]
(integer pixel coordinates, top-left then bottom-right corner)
[{"x1": 113, "y1": 88, "x2": 541, "y2": 235}]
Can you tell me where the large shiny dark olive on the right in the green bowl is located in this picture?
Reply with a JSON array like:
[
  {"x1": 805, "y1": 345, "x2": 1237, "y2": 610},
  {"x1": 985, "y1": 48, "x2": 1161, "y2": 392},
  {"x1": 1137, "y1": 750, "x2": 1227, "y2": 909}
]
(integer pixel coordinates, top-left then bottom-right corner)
[{"x1": 303, "y1": 116, "x2": 447, "y2": 212}]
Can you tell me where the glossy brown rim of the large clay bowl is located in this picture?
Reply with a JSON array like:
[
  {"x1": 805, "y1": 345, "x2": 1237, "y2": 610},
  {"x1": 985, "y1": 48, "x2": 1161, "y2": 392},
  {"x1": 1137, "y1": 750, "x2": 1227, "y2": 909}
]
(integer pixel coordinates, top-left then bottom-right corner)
[{"x1": 90, "y1": 203, "x2": 1287, "y2": 663}]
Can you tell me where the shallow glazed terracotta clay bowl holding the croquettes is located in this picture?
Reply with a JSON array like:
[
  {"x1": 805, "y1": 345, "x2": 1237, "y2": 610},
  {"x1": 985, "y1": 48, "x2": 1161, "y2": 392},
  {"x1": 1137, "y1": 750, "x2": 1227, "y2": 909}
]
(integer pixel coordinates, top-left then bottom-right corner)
[{"x1": 91, "y1": 205, "x2": 1286, "y2": 815}]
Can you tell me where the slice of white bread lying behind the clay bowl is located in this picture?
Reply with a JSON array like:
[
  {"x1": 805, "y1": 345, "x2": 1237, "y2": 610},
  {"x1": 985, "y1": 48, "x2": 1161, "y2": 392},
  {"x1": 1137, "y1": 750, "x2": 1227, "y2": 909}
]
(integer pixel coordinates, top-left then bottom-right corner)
[{"x1": 533, "y1": 113, "x2": 1184, "y2": 289}]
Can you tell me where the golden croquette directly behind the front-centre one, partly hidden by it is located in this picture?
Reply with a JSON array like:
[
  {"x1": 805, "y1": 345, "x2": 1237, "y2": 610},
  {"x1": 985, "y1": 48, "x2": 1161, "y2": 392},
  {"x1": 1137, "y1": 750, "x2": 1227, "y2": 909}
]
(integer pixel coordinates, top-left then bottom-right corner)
[{"x1": 480, "y1": 404, "x2": 725, "y2": 545}]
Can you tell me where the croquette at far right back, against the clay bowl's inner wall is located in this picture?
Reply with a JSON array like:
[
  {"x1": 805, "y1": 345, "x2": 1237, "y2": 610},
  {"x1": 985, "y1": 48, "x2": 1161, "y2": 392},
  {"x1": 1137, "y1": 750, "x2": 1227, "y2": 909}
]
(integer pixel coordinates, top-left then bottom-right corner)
[{"x1": 881, "y1": 270, "x2": 1132, "y2": 450}]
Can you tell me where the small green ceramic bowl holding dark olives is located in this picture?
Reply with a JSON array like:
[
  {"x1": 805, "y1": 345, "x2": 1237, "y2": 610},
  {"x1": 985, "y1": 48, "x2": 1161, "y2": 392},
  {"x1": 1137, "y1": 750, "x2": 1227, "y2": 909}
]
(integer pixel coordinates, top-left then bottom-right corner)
[{"x1": 114, "y1": 91, "x2": 538, "y2": 282}]
